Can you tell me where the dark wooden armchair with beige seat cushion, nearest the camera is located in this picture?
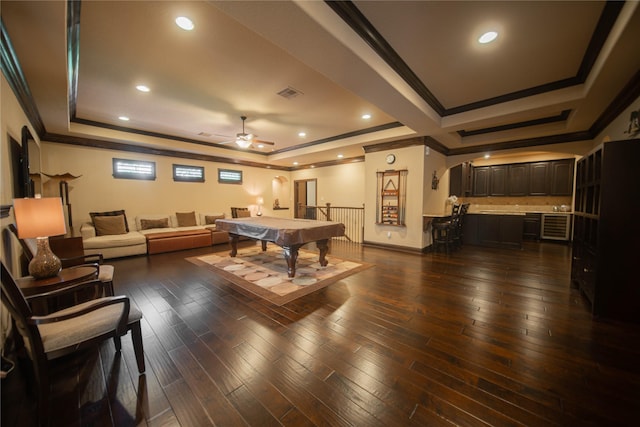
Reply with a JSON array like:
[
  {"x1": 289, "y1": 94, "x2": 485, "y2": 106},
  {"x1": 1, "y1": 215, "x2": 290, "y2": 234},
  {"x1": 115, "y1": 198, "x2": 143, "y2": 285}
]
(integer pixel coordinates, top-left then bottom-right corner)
[{"x1": 1, "y1": 263, "x2": 145, "y2": 424}]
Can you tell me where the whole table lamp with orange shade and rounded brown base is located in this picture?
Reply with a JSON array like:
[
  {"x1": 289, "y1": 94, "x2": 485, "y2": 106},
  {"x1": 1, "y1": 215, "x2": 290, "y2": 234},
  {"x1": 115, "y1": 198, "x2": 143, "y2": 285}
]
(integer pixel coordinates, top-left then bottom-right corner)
[{"x1": 13, "y1": 197, "x2": 67, "y2": 279}]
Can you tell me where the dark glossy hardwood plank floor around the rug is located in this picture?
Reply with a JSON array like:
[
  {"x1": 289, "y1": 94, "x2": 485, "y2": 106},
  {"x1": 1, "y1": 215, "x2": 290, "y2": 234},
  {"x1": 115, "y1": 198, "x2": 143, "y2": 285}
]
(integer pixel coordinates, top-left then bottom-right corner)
[{"x1": 2, "y1": 242, "x2": 640, "y2": 427}]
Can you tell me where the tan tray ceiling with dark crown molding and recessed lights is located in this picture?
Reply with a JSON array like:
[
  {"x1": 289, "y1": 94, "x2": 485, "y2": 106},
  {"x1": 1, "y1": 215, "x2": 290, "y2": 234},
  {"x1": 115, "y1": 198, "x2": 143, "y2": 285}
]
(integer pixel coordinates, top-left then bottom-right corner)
[{"x1": 0, "y1": 0, "x2": 640, "y2": 167}]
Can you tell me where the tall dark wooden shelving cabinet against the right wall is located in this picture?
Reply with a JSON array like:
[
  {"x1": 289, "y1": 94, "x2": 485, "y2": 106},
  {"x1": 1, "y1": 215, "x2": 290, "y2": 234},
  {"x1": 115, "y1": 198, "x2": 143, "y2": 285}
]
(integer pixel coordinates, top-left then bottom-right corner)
[{"x1": 571, "y1": 139, "x2": 640, "y2": 322}]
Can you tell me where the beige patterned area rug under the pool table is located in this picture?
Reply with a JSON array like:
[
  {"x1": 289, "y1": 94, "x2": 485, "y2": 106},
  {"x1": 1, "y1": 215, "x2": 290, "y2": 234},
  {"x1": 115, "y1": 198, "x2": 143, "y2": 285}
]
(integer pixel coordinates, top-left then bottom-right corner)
[{"x1": 186, "y1": 244, "x2": 372, "y2": 305}]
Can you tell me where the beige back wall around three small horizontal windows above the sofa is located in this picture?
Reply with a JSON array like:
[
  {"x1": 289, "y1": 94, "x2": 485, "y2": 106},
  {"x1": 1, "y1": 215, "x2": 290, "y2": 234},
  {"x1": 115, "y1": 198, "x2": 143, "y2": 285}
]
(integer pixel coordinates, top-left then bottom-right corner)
[{"x1": 41, "y1": 141, "x2": 289, "y2": 228}]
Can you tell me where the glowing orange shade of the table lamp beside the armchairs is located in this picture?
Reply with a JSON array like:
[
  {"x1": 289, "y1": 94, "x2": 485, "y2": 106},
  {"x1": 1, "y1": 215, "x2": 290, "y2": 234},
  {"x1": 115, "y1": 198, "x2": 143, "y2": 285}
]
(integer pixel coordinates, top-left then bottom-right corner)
[{"x1": 13, "y1": 197, "x2": 67, "y2": 239}]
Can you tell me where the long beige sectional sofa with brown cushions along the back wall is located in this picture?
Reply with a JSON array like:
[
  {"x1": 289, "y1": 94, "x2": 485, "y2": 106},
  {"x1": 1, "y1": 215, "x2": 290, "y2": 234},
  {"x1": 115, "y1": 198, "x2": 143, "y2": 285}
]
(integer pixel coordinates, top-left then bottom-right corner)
[{"x1": 80, "y1": 211, "x2": 229, "y2": 259}]
